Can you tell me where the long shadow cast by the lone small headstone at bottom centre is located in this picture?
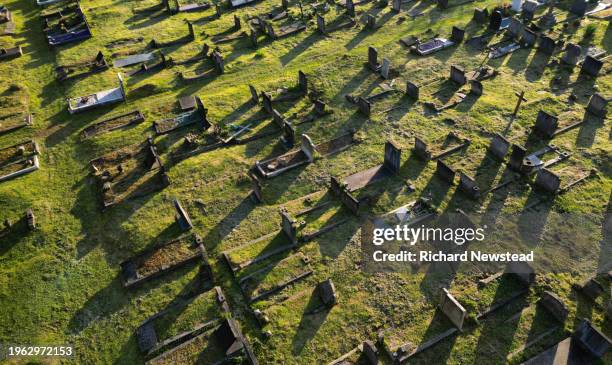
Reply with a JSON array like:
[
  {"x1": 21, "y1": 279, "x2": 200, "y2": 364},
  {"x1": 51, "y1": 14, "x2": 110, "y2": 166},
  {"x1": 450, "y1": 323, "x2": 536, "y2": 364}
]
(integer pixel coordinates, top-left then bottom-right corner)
[{"x1": 291, "y1": 288, "x2": 330, "y2": 356}]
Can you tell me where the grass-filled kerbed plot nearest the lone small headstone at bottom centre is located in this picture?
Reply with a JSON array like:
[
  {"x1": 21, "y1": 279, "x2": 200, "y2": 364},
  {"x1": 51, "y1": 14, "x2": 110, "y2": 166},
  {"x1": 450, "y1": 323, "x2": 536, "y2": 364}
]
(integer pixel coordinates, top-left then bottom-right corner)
[{"x1": 239, "y1": 253, "x2": 312, "y2": 303}]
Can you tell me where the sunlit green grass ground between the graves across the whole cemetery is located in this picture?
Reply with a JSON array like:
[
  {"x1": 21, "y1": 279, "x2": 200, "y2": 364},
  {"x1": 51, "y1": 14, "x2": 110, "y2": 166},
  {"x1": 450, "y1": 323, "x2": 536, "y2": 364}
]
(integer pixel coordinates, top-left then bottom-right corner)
[{"x1": 0, "y1": 0, "x2": 612, "y2": 364}]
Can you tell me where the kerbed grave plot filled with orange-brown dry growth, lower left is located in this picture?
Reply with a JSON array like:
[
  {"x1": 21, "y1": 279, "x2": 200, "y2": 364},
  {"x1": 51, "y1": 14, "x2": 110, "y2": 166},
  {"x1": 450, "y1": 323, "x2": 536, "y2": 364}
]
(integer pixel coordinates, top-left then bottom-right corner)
[{"x1": 121, "y1": 236, "x2": 205, "y2": 288}]
